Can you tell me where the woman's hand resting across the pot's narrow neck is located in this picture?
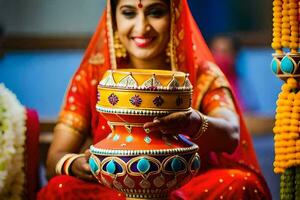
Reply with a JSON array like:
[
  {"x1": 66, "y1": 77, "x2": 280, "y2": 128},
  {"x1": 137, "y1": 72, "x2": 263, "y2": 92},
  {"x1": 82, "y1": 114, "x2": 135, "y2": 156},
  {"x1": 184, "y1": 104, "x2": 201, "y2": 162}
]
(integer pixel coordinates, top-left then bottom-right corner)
[{"x1": 144, "y1": 109, "x2": 202, "y2": 136}]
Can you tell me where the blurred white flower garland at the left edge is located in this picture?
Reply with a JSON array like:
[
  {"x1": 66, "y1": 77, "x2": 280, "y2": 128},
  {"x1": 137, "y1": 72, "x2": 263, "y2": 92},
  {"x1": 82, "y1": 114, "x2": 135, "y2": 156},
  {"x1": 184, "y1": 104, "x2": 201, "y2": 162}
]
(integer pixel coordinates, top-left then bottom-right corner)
[{"x1": 0, "y1": 84, "x2": 26, "y2": 200}]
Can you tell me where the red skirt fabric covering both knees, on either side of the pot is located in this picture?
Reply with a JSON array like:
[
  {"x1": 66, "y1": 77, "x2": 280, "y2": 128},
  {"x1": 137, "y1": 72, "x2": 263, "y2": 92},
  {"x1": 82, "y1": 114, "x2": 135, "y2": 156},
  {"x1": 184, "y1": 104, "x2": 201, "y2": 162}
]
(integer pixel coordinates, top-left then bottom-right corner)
[{"x1": 38, "y1": 169, "x2": 270, "y2": 200}]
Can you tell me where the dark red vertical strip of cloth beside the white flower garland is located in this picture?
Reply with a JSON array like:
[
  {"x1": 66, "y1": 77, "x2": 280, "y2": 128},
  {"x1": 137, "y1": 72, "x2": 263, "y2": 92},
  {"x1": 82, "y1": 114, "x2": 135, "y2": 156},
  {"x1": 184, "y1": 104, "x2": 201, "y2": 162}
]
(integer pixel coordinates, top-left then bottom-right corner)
[{"x1": 24, "y1": 109, "x2": 40, "y2": 200}]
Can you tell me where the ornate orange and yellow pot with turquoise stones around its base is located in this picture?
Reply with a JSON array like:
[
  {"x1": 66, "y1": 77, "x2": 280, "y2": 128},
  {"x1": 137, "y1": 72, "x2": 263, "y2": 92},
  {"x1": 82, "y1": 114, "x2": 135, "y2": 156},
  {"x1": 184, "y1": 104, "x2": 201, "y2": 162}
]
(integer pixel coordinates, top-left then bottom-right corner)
[{"x1": 89, "y1": 69, "x2": 200, "y2": 199}]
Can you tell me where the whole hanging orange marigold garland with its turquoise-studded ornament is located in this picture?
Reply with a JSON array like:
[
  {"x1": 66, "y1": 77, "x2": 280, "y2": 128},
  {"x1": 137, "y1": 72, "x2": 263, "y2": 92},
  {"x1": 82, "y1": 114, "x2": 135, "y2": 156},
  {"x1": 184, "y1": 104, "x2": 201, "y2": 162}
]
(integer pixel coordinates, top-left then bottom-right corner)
[{"x1": 271, "y1": 0, "x2": 300, "y2": 197}]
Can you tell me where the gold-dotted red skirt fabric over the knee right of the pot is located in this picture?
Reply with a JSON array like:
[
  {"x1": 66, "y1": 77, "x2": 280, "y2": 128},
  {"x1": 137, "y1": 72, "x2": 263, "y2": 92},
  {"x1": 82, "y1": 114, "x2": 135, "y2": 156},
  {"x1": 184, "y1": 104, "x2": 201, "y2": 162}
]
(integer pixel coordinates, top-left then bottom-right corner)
[{"x1": 170, "y1": 169, "x2": 271, "y2": 200}]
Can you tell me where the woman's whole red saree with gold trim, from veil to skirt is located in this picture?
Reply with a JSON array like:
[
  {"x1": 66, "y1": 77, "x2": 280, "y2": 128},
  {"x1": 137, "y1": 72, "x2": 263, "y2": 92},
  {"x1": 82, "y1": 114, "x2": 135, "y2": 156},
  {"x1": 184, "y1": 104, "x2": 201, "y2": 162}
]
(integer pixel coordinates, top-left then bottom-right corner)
[{"x1": 38, "y1": 0, "x2": 271, "y2": 200}]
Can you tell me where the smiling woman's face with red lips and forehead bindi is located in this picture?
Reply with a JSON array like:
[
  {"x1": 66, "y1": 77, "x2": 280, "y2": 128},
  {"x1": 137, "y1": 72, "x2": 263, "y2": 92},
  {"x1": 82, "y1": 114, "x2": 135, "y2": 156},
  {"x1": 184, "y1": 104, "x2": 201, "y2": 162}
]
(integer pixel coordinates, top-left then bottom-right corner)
[{"x1": 116, "y1": 0, "x2": 170, "y2": 60}]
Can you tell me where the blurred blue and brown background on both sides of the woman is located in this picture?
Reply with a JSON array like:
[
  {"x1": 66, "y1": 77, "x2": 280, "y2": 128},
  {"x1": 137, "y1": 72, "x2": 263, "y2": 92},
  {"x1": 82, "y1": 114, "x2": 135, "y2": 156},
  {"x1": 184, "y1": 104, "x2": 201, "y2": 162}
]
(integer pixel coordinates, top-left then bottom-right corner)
[{"x1": 0, "y1": 0, "x2": 281, "y2": 199}]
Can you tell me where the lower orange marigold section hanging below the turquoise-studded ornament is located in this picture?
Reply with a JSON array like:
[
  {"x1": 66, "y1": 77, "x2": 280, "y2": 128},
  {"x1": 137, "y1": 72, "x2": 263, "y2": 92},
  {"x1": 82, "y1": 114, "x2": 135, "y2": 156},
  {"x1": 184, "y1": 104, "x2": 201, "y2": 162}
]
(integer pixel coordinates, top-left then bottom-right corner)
[{"x1": 273, "y1": 78, "x2": 300, "y2": 173}]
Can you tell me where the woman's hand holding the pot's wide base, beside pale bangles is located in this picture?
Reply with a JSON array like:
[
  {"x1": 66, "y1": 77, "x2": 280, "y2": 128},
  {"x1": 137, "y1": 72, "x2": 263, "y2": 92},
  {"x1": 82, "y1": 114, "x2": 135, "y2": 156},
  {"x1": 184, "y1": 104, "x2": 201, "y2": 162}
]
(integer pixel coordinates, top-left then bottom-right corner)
[{"x1": 70, "y1": 150, "x2": 96, "y2": 181}]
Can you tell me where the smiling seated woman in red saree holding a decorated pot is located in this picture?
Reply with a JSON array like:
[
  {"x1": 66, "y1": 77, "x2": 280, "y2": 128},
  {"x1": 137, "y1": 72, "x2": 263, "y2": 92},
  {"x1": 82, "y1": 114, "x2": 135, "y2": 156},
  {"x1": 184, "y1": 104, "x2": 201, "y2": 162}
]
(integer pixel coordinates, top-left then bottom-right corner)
[{"x1": 39, "y1": 0, "x2": 270, "y2": 199}]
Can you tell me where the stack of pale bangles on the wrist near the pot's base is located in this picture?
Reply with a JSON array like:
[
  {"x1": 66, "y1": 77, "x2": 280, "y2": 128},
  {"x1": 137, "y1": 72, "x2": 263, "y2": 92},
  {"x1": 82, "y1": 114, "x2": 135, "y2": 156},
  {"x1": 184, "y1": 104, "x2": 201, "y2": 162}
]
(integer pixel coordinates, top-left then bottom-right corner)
[{"x1": 55, "y1": 153, "x2": 85, "y2": 175}]
